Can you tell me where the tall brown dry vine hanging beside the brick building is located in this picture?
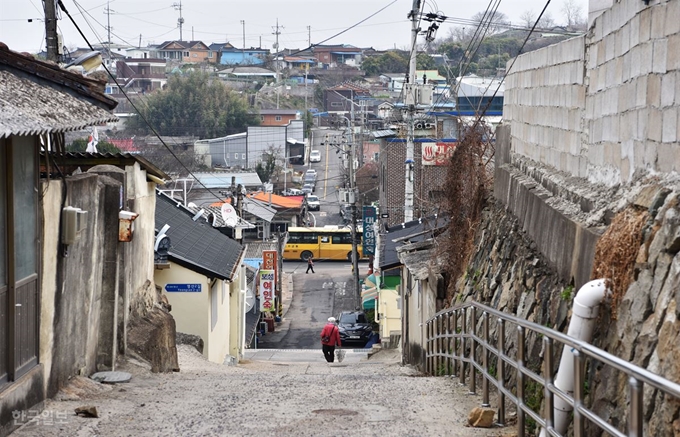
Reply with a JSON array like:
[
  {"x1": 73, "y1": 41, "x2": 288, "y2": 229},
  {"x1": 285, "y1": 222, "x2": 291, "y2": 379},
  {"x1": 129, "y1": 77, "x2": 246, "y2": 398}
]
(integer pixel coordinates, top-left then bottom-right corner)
[{"x1": 445, "y1": 122, "x2": 494, "y2": 302}]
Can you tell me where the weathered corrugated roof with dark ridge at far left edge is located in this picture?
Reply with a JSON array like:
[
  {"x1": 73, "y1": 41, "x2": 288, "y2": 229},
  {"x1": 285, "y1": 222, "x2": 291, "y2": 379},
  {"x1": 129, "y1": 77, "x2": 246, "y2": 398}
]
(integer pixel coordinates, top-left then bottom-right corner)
[{"x1": 0, "y1": 43, "x2": 118, "y2": 138}]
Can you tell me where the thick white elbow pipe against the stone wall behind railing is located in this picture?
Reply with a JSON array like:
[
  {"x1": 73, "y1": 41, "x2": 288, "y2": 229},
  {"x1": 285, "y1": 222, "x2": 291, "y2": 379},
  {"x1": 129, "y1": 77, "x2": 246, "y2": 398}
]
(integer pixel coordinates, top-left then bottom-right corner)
[{"x1": 540, "y1": 279, "x2": 610, "y2": 437}]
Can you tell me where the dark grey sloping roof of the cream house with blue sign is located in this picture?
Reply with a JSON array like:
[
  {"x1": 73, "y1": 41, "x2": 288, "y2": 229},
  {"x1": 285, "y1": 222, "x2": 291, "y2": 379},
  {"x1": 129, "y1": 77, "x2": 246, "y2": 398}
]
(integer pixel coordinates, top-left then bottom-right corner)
[{"x1": 155, "y1": 192, "x2": 244, "y2": 281}]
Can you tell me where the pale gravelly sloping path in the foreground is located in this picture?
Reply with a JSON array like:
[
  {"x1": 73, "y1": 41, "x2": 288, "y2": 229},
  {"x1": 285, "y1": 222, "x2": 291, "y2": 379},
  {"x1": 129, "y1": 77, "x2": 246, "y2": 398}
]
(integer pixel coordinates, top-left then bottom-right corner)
[{"x1": 13, "y1": 346, "x2": 509, "y2": 437}]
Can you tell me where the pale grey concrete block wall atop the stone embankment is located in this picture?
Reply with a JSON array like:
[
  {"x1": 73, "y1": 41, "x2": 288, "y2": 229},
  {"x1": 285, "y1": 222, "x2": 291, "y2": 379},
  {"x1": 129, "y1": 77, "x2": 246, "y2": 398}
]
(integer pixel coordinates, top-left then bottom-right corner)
[{"x1": 504, "y1": 0, "x2": 680, "y2": 186}]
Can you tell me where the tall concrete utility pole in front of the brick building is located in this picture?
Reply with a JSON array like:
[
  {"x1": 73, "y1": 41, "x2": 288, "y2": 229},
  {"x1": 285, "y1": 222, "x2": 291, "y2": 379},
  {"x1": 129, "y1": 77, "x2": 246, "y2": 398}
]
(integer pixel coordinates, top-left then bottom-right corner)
[{"x1": 404, "y1": 0, "x2": 421, "y2": 222}]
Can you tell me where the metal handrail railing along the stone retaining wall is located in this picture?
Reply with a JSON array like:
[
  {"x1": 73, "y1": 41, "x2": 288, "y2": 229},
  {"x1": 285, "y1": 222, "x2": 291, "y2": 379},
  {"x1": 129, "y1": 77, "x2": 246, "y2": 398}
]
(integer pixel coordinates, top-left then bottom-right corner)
[{"x1": 425, "y1": 302, "x2": 680, "y2": 437}]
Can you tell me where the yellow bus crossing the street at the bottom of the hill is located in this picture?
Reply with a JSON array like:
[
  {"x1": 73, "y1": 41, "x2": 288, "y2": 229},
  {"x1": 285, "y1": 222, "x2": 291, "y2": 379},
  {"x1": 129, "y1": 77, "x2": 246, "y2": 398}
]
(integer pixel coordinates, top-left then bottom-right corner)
[{"x1": 283, "y1": 226, "x2": 363, "y2": 261}]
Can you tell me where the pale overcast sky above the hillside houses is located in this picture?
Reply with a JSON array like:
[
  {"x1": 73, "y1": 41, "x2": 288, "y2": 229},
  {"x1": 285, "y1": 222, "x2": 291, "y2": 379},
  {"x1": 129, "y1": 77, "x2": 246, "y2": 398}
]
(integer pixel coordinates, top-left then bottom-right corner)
[{"x1": 0, "y1": 0, "x2": 588, "y2": 52}]
